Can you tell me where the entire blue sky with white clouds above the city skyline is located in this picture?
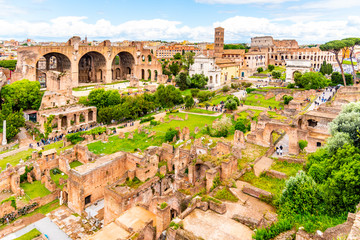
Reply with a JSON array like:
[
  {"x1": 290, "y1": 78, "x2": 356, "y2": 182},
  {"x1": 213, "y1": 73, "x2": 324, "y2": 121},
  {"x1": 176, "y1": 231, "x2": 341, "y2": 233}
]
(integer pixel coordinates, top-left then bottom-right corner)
[{"x1": 0, "y1": 0, "x2": 360, "y2": 44}]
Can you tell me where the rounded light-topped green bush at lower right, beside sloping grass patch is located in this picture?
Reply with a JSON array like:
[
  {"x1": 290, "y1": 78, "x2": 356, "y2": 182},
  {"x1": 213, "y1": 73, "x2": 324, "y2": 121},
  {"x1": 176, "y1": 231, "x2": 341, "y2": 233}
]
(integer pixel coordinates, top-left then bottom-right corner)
[{"x1": 279, "y1": 171, "x2": 322, "y2": 214}]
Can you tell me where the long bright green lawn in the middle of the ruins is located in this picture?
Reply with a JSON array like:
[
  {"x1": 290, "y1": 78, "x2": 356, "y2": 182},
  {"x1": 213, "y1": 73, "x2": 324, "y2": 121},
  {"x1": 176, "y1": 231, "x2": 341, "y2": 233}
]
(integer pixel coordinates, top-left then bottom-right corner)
[{"x1": 88, "y1": 113, "x2": 218, "y2": 154}]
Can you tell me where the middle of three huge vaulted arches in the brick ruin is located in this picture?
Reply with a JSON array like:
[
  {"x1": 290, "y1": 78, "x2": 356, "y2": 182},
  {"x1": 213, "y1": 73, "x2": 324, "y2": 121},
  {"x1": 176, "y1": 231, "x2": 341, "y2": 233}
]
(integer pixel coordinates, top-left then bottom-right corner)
[{"x1": 79, "y1": 51, "x2": 106, "y2": 83}]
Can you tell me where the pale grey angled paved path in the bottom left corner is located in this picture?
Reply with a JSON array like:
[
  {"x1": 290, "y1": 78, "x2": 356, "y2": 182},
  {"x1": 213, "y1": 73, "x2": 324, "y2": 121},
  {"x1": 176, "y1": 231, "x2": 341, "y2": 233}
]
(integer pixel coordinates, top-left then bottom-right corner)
[{"x1": 2, "y1": 217, "x2": 71, "y2": 240}]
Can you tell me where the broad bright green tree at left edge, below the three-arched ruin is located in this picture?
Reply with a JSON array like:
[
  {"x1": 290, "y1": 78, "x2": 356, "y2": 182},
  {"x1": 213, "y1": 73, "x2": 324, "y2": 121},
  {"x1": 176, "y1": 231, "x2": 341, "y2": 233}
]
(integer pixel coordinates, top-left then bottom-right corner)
[{"x1": 1, "y1": 79, "x2": 43, "y2": 111}]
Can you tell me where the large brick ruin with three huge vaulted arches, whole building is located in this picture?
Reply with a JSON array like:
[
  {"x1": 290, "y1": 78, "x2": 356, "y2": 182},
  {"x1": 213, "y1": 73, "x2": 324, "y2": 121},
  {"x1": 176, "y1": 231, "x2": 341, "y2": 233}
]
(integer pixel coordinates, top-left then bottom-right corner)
[{"x1": 12, "y1": 37, "x2": 167, "y2": 90}]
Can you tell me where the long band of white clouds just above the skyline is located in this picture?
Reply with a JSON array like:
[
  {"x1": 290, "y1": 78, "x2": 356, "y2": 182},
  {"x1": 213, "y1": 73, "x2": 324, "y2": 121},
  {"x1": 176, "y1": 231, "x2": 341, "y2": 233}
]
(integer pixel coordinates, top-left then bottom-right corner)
[{"x1": 0, "y1": 14, "x2": 360, "y2": 43}]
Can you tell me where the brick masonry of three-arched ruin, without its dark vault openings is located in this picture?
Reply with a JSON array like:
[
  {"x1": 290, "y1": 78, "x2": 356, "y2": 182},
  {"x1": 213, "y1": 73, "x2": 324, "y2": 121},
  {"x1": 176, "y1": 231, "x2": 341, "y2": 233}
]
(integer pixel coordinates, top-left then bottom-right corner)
[{"x1": 12, "y1": 37, "x2": 167, "y2": 90}]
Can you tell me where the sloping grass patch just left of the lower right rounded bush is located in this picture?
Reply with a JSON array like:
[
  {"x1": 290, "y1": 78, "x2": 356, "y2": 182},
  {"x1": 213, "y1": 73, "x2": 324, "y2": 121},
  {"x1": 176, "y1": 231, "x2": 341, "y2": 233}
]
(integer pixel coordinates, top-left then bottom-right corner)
[{"x1": 240, "y1": 171, "x2": 285, "y2": 198}]
